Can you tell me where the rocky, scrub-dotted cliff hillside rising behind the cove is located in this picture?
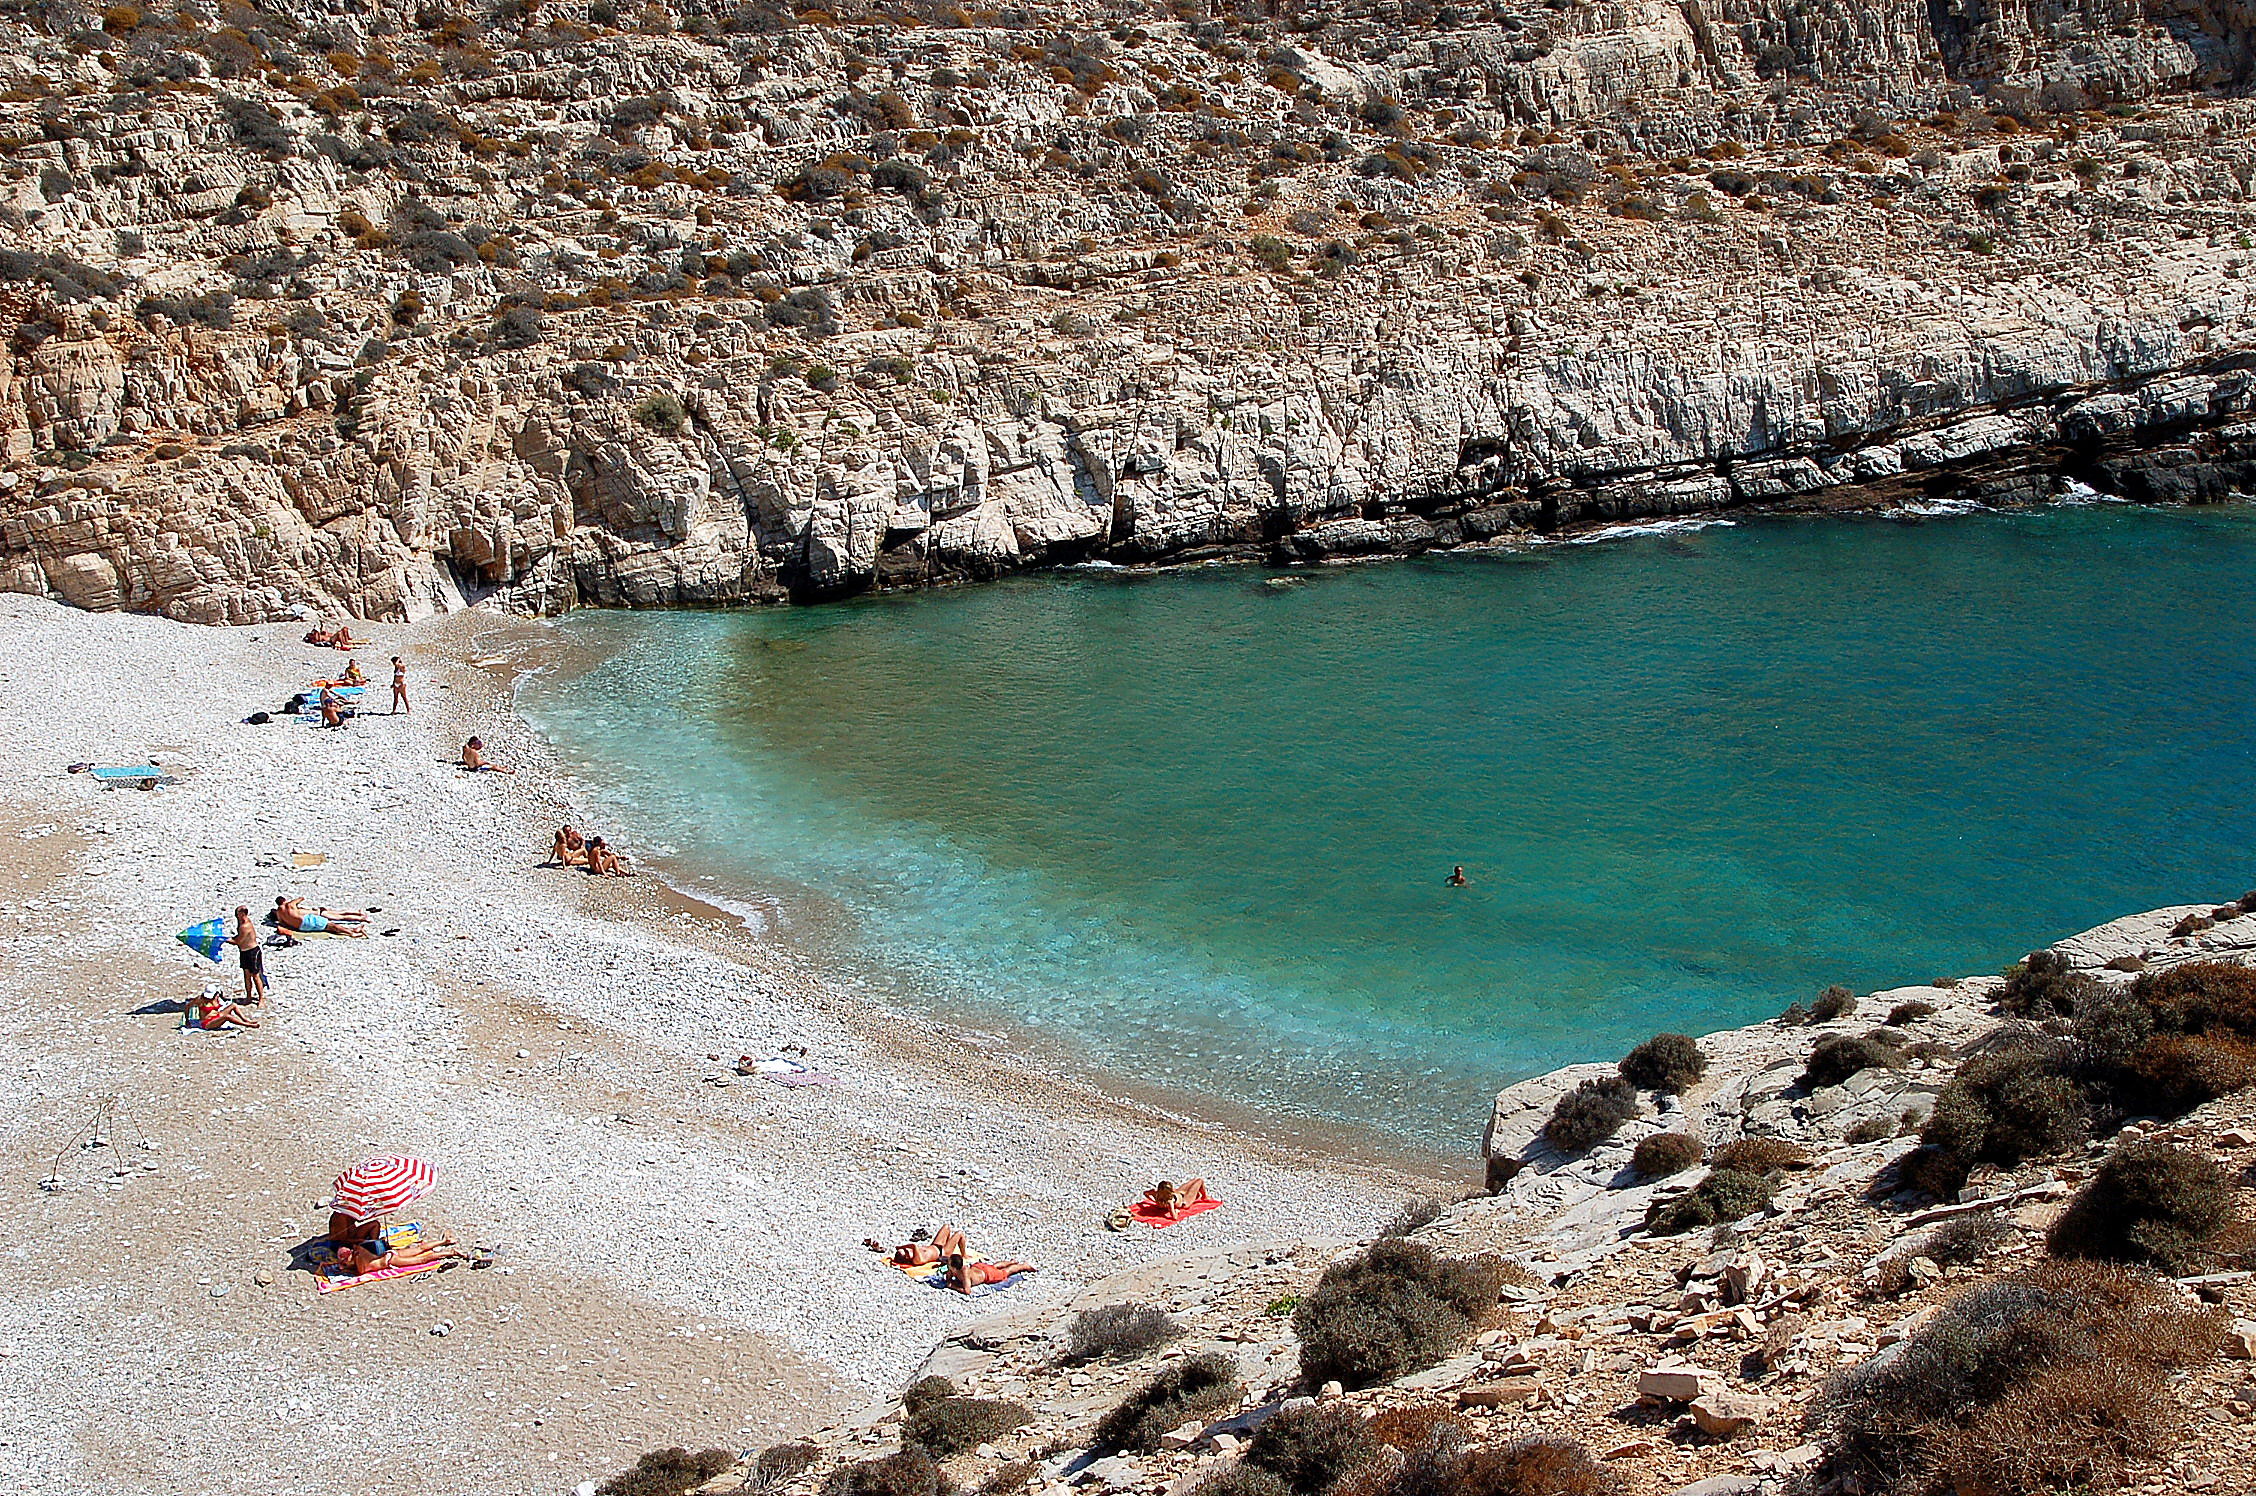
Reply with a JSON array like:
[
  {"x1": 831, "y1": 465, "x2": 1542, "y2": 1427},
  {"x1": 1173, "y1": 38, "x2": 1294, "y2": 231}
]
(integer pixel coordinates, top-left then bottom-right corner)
[{"x1": 0, "y1": 0, "x2": 2256, "y2": 623}]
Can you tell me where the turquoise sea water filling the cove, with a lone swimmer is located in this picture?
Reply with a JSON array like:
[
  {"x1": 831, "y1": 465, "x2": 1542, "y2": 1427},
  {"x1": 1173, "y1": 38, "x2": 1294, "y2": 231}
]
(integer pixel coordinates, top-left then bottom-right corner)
[{"x1": 521, "y1": 505, "x2": 2256, "y2": 1146}]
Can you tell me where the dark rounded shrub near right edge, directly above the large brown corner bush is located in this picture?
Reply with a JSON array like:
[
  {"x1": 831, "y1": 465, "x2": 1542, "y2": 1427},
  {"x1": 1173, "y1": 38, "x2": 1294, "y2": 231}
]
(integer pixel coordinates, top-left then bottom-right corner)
[{"x1": 2044, "y1": 1142, "x2": 2233, "y2": 1273}]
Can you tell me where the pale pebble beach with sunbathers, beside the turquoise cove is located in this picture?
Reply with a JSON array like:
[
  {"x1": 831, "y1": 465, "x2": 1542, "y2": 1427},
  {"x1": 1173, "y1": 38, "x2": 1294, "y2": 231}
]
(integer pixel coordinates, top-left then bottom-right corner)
[{"x1": 0, "y1": 596, "x2": 1443, "y2": 1496}]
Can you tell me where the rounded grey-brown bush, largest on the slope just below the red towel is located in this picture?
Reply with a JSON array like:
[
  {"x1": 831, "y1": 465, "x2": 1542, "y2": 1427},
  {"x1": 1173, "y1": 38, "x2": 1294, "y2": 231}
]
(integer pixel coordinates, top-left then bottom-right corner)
[{"x1": 1293, "y1": 1239, "x2": 1505, "y2": 1388}]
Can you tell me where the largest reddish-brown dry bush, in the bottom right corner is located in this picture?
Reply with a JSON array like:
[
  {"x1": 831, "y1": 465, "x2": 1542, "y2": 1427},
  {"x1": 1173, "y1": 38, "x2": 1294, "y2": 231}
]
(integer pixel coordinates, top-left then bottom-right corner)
[{"x1": 1807, "y1": 1261, "x2": 2224, "y2": 1496}]
